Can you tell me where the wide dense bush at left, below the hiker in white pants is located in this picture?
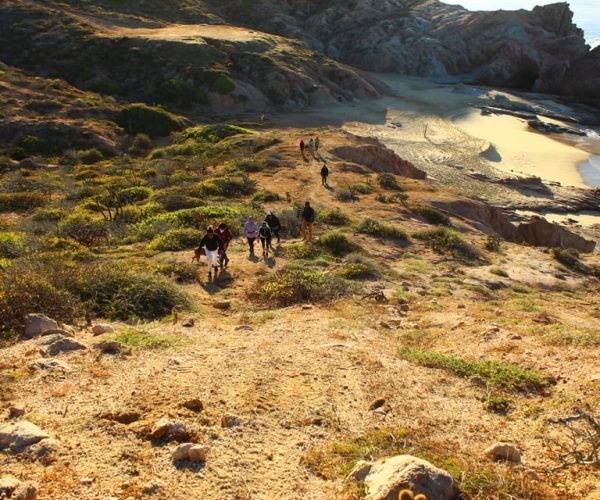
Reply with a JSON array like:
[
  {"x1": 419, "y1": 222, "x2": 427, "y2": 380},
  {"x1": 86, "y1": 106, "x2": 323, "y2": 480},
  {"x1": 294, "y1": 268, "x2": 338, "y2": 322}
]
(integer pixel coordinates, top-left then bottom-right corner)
[{"x1": 64, "y1": 262, "x2": 188, "y2": 320}]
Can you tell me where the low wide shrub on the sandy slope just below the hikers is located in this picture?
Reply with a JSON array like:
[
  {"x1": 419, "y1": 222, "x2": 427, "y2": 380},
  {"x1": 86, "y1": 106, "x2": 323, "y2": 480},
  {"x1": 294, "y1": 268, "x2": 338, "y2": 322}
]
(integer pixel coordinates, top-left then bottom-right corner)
[{"x1": 254, "y1": 270, "x2": 353, "y2": 306}]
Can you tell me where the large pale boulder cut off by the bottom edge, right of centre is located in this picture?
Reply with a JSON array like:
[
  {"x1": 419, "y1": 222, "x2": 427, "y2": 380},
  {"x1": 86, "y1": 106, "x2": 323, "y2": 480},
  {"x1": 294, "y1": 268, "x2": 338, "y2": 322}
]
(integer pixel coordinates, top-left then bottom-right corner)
[{"x1": 350, "y1": 455, "x2": 457, "y2": 500}]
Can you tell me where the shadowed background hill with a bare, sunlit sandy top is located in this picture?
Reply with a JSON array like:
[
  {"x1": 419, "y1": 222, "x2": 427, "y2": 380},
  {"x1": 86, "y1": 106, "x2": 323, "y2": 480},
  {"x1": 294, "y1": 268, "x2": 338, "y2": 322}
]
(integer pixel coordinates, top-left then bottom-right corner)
[{"x1": 0, "y1": 0, "x2": 382, "y2": 111}]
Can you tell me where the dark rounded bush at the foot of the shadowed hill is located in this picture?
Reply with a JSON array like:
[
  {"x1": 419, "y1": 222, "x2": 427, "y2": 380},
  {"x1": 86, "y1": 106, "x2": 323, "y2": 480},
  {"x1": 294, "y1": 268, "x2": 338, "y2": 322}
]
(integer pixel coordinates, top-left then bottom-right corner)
[{"x1": 117, "y1": 103, "x2": 187, "y2": 137}]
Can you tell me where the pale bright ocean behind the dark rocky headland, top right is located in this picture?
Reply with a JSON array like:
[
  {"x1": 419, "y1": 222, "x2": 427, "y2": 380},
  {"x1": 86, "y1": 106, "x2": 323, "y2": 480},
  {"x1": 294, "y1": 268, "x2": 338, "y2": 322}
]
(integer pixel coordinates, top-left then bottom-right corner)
[{"x1": 446, "y1": 0, "x2": 600, "y2": 47}]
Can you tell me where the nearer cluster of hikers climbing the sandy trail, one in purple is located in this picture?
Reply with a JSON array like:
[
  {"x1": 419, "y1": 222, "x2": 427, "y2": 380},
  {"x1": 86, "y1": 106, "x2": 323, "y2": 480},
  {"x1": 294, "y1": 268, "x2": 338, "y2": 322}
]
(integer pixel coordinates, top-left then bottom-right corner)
[{"x1": 194, "y1": 201, "x2": 315, "y2": 279}]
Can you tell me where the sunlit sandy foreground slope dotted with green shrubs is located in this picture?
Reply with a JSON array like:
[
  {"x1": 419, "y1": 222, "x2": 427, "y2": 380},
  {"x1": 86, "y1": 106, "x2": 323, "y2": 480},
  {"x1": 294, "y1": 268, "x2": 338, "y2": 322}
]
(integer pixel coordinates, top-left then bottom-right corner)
[{"x1": 0, "y1": 62, "x2": 600, "y2": 499}]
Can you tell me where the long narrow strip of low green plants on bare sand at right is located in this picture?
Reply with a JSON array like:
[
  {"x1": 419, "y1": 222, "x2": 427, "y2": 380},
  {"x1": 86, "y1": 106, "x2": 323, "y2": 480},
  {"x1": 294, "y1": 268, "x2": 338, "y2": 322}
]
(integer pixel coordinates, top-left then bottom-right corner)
[{"x1": 398, "y1": 347, "x2": 549, "y2": 392}]
